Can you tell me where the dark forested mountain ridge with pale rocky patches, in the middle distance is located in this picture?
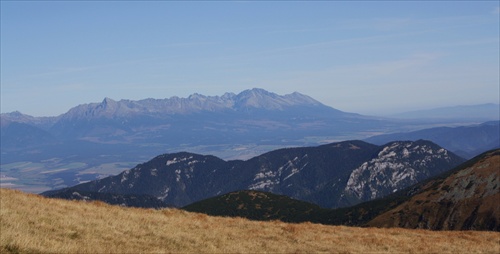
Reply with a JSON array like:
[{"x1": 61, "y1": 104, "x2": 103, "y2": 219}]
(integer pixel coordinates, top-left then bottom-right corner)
[{"x1": 43, "y1": 140, "x2": 464, "y2": 208}]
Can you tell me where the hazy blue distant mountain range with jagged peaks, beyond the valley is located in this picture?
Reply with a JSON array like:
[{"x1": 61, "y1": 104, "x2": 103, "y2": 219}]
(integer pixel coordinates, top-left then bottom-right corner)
[{"x1": 1, "y1": 89, "x2": 393, "y2": 156}]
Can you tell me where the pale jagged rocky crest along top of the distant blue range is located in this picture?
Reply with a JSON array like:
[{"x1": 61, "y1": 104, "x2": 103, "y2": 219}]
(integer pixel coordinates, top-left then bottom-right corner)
[{"x1": 57, "y1": 88, "x2": 323, "y2": 119}]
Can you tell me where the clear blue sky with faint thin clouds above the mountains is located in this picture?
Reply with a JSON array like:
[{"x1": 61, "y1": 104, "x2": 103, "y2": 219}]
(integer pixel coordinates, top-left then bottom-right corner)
[{"x1": 0, "y1": 1, "x2": 500, "y2": 116}]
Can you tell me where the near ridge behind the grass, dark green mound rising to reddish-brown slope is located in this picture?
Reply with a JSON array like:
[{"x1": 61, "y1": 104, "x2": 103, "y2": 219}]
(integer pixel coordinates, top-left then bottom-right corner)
[{"x1": 183, "y1": 149, "x2": 500, "y2": 231}]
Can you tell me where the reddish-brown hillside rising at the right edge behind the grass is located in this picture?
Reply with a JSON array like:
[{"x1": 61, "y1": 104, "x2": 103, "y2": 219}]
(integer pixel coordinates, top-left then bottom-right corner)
[{"x1": 368, "y1": 150, "x2": 500, "y2": 231}]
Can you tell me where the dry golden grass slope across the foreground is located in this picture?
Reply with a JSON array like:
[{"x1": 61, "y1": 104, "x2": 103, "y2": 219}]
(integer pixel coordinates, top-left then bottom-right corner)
[{"x1": 0, "y1": 189, "x2": 500, "y2": 253}]
